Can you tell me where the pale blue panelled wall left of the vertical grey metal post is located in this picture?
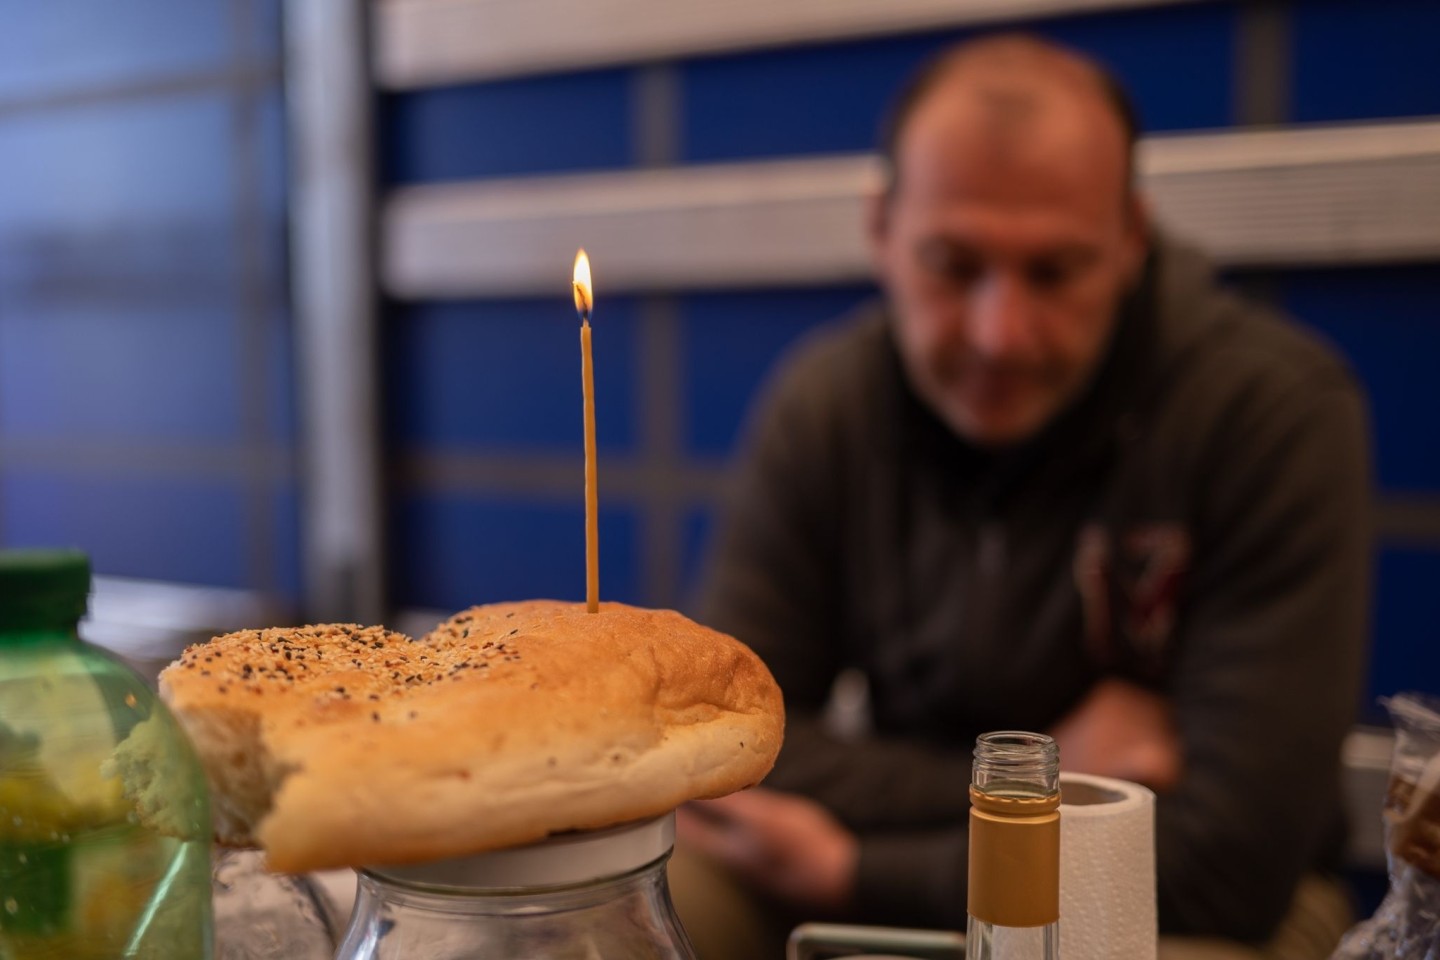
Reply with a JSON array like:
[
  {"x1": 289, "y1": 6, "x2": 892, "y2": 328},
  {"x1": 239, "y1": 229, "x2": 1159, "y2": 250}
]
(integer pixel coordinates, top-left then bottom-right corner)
[{"x1": 0, "y1": 0, "x2": 300, "y2": 600}]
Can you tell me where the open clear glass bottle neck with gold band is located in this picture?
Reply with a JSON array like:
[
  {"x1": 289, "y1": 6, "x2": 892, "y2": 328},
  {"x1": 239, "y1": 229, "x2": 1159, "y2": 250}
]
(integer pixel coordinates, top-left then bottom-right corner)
[{"x1": 965, "y1": 730, "x2": 1060, "y2": 960}]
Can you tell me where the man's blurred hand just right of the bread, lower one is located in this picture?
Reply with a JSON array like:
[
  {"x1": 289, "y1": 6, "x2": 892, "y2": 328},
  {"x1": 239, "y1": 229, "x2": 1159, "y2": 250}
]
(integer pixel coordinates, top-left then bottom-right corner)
[{"x1": 675, "y1": 787, "x2": 860, "y2": 915}]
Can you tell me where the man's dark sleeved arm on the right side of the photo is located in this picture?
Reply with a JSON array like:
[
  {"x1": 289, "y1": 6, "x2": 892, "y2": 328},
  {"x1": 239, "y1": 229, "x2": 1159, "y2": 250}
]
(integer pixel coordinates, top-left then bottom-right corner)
[{"x1": 1156, "y1": 381, "x2": 1371, "y2": 940}]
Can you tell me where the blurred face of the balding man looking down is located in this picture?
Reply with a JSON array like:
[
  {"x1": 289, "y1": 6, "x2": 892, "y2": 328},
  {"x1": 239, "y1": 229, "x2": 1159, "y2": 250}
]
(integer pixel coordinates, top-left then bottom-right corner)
[{"x1": 871, "y1": 82, "x2": 1145, "y2": 446}]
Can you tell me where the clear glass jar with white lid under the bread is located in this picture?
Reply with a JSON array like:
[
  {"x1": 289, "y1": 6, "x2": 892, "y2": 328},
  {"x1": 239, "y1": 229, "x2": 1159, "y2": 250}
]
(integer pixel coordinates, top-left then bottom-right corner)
[{"x1": 336, "y1": 813, "x2": 696, "y2": 960}]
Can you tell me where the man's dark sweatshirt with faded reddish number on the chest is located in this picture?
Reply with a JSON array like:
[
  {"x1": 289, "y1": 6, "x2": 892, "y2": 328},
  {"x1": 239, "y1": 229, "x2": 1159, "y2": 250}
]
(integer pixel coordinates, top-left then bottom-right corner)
[{"x1": 701, "y1": 236, "x2": 1371, "y2": 940}]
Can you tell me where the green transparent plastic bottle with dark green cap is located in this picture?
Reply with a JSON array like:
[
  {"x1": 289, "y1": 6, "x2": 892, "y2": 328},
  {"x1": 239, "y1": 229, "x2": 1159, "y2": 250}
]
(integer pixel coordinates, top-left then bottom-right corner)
[{"x1": 0, "y1": 550, "x2": 212, "y2": 960}]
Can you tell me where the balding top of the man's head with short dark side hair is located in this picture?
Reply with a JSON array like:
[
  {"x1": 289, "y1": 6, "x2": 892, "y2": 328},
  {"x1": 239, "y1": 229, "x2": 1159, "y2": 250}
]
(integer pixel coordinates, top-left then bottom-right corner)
[{"x1": 880, "y1": 33, "x2": 1138, "y2": 201}]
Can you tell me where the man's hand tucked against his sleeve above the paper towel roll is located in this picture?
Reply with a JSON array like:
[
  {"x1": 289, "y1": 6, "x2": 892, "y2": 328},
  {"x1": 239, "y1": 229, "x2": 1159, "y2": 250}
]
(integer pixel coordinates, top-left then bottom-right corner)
[{"x1": 1050, "y1": 678, "x2": 1184, "y2": 793}]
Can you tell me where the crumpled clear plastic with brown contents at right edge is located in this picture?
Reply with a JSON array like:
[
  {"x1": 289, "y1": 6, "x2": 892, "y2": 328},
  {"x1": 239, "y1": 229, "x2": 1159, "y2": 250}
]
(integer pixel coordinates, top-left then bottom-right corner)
[{"x1": 1331, "y1": 694, "x2": 1440, "y2": 960}]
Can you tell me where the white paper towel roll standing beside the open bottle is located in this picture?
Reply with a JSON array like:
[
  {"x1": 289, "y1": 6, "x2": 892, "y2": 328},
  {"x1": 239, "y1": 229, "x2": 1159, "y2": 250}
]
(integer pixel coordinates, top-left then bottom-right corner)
[{"x1": 1060, "y1": 773, "x2": 1156, "y2": 960}]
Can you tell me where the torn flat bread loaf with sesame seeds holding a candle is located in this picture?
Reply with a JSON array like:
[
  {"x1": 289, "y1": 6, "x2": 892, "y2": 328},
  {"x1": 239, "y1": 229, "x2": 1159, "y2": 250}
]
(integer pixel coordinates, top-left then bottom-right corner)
[{"x1": 160, "y1": 600, "x2": 783, "y2": 872}]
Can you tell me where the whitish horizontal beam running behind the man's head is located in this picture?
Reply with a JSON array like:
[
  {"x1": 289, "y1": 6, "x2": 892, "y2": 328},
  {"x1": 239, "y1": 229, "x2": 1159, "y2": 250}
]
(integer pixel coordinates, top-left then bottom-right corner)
[{"x1": 382, "y1": 121, "x2": 1440, "y2": 298}]
